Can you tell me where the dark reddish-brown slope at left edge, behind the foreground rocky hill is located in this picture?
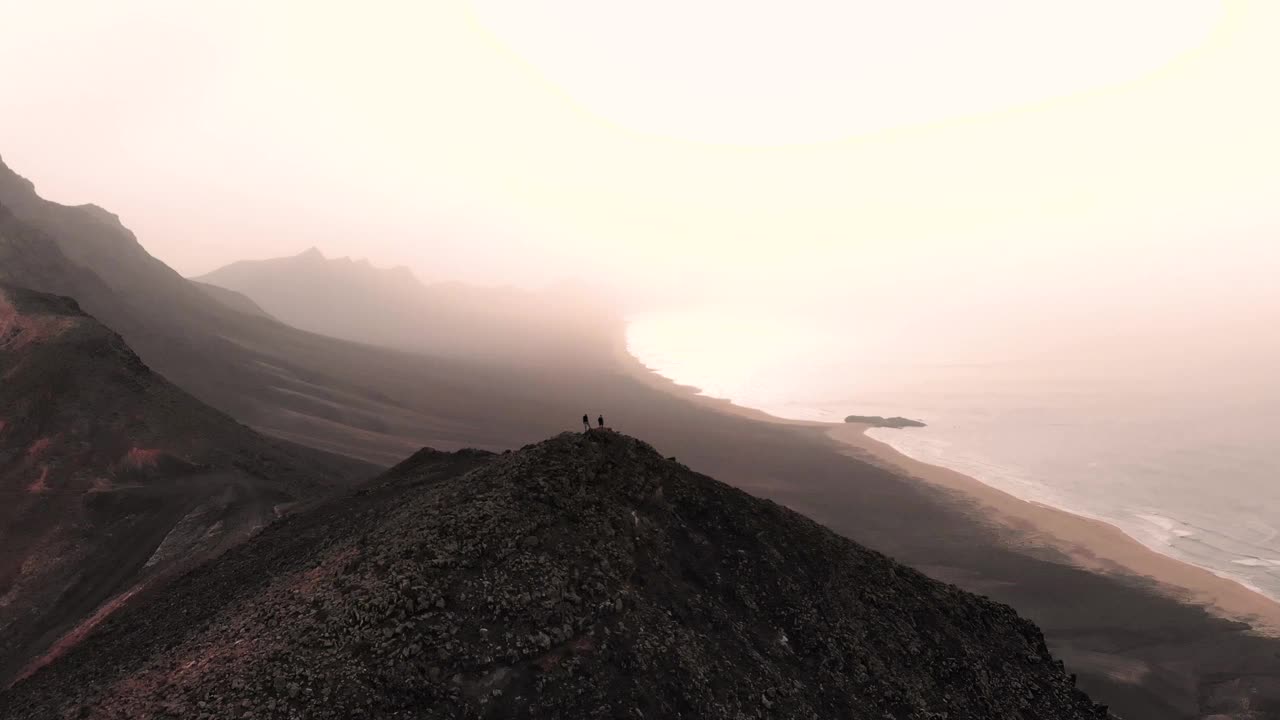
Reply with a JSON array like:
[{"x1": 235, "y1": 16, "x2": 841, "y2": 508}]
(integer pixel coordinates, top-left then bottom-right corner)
[{"x1": 0, "y1": 286, "x2": 372, "y2": 687}]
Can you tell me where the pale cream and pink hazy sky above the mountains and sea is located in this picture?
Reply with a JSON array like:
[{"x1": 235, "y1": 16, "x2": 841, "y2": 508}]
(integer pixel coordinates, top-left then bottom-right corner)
[{"x1": 0, "y1": 0, "x2": 1280, "y2": 319}]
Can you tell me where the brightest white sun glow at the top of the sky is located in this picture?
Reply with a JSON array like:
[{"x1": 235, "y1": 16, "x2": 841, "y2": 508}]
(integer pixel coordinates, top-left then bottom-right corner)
[{"x1": 475, "y1": 0, "x2": 1222, "y2": 142}]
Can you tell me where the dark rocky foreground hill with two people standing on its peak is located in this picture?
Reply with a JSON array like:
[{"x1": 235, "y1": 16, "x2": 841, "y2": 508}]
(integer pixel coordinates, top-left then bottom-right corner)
[{"x1": 0, "y1": 430, "x2": 1106, "y2": 720}]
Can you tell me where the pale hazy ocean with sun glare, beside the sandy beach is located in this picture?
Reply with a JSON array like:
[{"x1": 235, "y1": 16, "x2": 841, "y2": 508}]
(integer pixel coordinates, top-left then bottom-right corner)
[{"x1": 627, "y1": 306, "x2": 1280, "y2": 601}]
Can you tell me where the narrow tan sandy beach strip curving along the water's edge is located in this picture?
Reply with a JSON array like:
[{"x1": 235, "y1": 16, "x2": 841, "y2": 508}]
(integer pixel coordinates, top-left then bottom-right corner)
[{"x1": 616, "y1": 338, "x2": 1280, "y2": 637}]
